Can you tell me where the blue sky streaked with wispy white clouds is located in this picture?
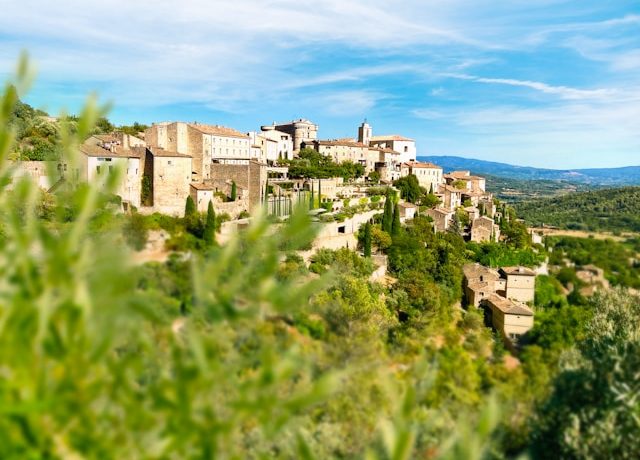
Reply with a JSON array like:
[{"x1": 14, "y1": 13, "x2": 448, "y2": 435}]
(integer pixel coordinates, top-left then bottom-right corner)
[{"x1": 0, "y1": 0, "x2": 640, "y2": 168}]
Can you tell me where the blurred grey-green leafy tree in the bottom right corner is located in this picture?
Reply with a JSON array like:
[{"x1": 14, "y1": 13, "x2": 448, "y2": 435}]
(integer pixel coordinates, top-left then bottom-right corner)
[{"x1": 531, "y1": 291, "x2": 640, "y2": 459}]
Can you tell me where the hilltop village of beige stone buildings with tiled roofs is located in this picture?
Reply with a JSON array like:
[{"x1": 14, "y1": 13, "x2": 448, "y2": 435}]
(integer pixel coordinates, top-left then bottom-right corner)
[{"x1": 11, "y1": 119, "x2": 535, "y2": 346}]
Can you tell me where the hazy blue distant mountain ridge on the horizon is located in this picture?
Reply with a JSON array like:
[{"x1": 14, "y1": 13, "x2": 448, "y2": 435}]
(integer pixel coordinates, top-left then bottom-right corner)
[{"x1": 418, "y1": 156, "x2": 640, "y2": 186}]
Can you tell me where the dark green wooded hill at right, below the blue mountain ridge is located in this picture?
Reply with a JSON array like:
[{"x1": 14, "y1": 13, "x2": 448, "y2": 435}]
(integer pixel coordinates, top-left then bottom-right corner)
[{"x1": 515, "y1": 187, "x2": 640, "y2": 232}]
